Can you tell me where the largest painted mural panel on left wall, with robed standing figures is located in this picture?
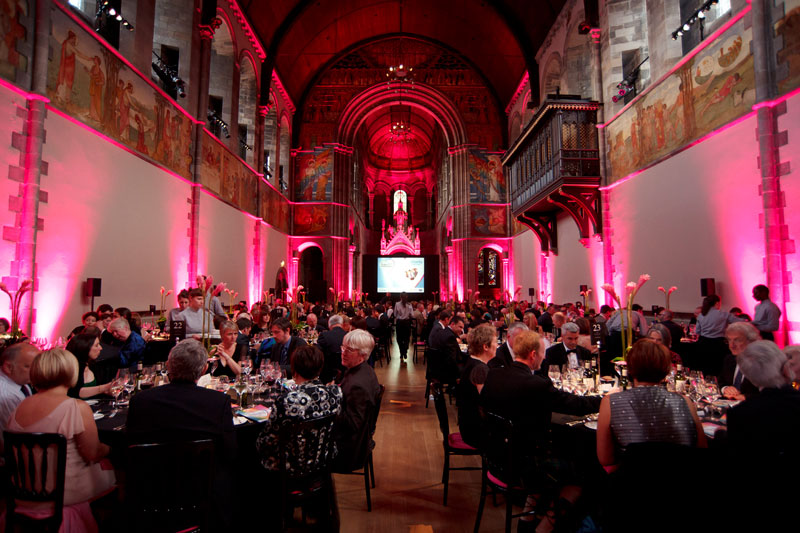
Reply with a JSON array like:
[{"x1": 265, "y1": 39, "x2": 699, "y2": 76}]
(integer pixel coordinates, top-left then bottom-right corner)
[{"x1": 47, "y1": 7, "x2": 192, "y2": 179}]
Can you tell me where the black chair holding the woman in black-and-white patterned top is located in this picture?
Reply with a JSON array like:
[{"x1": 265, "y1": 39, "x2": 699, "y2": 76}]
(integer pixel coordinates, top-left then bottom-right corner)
[{"x1": 278, "y1": 414, "x2": 339, "y2": 531}]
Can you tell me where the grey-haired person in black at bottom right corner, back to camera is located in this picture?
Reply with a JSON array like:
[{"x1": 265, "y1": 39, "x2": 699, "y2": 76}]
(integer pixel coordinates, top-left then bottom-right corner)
[{"x1": 723, "y1": 340, "x2": 800, "y2": 531}]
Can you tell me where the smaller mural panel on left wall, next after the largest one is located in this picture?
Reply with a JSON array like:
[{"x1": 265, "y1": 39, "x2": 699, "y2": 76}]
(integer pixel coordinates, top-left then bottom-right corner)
[{"x1": 200, "y1": 132, "x2": 258, "y2": 215}]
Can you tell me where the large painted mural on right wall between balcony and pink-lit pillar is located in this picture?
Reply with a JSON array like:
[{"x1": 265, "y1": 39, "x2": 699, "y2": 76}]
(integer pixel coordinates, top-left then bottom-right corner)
[{"x1": 606, "y1": 21, "x2": 755, "y2": 182}]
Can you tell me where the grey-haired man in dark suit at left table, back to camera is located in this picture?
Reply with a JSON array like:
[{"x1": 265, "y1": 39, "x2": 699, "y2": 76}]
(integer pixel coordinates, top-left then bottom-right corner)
[{"x1": 126, "y1": 339, "x2": 236, "y2": 530}]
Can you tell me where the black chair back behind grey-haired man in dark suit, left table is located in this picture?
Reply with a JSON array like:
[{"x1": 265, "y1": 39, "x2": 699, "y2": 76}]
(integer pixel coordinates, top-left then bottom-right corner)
[{"x1": 125, "y1": 439, "x2": 216, "y2": 532}]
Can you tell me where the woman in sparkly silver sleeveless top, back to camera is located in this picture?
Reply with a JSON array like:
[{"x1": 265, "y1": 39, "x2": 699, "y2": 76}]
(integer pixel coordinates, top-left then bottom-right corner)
[{"x1": 597, "y1": 339, "x2": 706, "y2": 470}]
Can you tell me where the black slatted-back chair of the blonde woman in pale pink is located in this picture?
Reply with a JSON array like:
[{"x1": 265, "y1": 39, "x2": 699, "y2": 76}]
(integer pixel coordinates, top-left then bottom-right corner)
[{"x1": 3, "y1": 431, "x2": 67, "y2": 532}]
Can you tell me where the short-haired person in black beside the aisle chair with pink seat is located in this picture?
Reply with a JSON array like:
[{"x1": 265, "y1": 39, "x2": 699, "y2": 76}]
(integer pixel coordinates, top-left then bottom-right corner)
[{"x1": 456, "y1": 324, "x2": 494, "y2": 448}]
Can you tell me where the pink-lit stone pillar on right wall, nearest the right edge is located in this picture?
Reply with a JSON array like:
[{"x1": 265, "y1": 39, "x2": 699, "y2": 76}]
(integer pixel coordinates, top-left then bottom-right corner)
[{"x1": 751, "y1": 0, "x2": 791, "y2": 345}]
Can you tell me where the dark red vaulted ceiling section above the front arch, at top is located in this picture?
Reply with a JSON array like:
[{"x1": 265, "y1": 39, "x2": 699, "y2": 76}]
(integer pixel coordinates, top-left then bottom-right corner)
[{"x1": 240, "y1": 0, "x2": 566, "y2": 106}]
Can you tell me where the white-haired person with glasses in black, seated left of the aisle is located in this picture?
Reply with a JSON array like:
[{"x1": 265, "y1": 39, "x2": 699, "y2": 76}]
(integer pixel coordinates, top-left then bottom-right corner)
[{"x1": 334, "y1": 329, "x2": 380, "y2": 472}]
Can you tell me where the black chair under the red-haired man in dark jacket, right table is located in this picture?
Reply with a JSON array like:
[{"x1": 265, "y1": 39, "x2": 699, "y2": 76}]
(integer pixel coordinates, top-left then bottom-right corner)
[{"x1": 475, "y1": 413, "x2": 550, "y2": 533}]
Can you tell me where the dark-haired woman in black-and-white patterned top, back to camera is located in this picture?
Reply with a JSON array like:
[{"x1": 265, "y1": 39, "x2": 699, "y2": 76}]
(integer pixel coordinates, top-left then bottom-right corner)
[{"x1": 256, "y1": 345, "x2": 342, "y2": 472}]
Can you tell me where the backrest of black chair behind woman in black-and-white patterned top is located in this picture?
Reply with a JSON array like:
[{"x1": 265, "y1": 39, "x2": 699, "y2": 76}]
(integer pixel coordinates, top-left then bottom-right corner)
[{"x1": 278, "y1": 414, "x2": 336, "y2": 478}]
